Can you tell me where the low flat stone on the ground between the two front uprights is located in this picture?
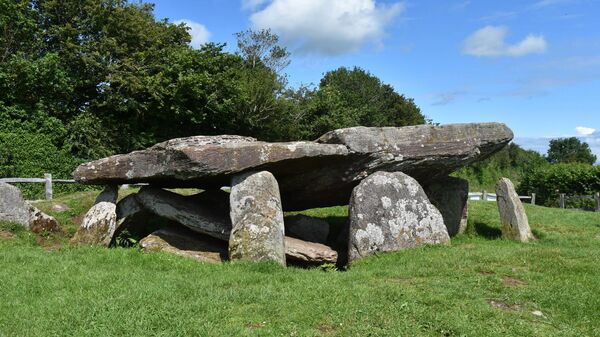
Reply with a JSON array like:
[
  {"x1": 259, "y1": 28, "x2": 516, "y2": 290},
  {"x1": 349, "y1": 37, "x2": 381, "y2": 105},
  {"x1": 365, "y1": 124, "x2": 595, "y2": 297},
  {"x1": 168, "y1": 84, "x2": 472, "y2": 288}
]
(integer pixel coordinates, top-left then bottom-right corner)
[{"x1": 285, "y1": 237, "x2": 338, "y2": 264}]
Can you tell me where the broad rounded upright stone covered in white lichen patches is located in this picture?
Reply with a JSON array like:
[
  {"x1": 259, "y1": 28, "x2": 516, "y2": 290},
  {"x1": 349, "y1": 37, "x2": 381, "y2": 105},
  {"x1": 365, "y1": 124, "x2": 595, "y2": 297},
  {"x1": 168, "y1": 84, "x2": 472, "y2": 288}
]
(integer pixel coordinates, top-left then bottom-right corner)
[{"x1": 348, "y1": 172, "x2": 450, "y2": 263}]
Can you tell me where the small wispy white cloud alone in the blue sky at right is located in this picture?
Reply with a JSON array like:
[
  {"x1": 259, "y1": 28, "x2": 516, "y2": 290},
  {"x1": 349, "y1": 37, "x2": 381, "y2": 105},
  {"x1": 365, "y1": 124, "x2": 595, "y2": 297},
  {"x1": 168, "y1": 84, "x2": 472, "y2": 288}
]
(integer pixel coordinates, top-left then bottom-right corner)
[{"x1": 463, "y1": 26, "x2": 548, "y2": 57}]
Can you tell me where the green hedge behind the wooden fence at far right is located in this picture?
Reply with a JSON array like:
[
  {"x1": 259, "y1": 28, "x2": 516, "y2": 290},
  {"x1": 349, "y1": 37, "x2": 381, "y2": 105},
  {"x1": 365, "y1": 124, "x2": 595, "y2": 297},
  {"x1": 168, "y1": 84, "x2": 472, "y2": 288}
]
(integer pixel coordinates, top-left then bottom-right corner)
[{"x1": 519, "y1": 163, "x2": 600, "y2": 208}]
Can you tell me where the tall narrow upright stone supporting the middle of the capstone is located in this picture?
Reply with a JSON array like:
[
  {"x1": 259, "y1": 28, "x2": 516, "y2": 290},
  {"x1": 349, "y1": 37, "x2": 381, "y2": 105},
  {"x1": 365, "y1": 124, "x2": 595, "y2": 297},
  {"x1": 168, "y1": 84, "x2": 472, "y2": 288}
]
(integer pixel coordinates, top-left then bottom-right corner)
[{"x1": 229, "y1": 171, "x2": 285, "y2": 266}]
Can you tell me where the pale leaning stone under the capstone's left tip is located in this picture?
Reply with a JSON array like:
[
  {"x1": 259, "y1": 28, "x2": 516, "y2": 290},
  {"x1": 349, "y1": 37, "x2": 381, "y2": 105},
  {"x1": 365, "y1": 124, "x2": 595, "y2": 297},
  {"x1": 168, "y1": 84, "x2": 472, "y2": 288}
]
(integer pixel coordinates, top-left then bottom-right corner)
[{"x1": 71, "y1": 201, "x2": 117, "y2": 247}]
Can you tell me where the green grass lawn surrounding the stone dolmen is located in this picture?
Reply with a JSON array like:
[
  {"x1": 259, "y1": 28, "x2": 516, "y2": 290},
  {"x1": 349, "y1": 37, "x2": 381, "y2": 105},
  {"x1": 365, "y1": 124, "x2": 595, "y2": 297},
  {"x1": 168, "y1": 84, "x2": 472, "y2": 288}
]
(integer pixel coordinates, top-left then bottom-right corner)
[{"x1": 0, "y1": 193, "x2": 600, "y2": 336}]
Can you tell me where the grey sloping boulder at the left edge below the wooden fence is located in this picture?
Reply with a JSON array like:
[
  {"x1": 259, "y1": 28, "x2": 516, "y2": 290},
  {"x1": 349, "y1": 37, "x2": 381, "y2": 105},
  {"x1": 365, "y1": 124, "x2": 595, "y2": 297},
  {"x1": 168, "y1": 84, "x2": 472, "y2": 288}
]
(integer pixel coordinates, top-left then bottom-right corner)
[{"x1": 0, "y1": 183, "x2": 62, "y2": 233}]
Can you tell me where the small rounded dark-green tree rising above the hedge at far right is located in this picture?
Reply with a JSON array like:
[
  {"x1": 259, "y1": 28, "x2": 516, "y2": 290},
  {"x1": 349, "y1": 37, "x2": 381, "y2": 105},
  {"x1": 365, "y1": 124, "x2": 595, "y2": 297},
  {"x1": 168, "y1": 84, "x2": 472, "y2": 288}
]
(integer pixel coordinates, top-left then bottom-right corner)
[{"x1": 548, "y1": 137, "x2": 597, "y2": 165}]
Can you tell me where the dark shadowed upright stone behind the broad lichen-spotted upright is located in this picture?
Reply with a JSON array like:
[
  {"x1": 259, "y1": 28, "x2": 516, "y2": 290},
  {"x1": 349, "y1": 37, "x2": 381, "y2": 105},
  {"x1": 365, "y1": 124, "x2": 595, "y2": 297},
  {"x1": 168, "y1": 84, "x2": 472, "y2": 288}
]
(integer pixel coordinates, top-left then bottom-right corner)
[{"x1": 423, "y1": 177, "x2": 469, "y2": 236}]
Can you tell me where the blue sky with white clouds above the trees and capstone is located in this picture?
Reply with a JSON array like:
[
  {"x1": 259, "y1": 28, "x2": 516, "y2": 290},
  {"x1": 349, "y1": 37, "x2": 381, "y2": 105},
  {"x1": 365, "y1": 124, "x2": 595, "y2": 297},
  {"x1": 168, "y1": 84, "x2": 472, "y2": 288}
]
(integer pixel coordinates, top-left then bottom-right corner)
[{"x1": 150, "y1": 0, "x2": 600, "y2": 157}]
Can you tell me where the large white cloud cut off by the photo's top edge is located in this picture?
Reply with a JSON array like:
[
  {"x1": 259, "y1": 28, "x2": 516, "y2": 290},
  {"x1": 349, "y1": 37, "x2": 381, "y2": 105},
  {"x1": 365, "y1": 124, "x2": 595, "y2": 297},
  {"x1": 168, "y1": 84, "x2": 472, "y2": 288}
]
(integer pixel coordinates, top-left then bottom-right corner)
[{"x1": 246, "y1": 0, "x2": 404, "y2": 55}]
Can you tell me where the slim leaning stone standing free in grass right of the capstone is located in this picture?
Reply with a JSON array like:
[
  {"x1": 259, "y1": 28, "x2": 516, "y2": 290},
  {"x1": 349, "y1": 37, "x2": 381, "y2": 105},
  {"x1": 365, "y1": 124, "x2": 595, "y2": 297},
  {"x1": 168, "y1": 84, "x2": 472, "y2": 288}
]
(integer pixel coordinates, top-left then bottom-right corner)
[{"x1": 496, "y1": 178, "x2": 534, "y2": 242}]
